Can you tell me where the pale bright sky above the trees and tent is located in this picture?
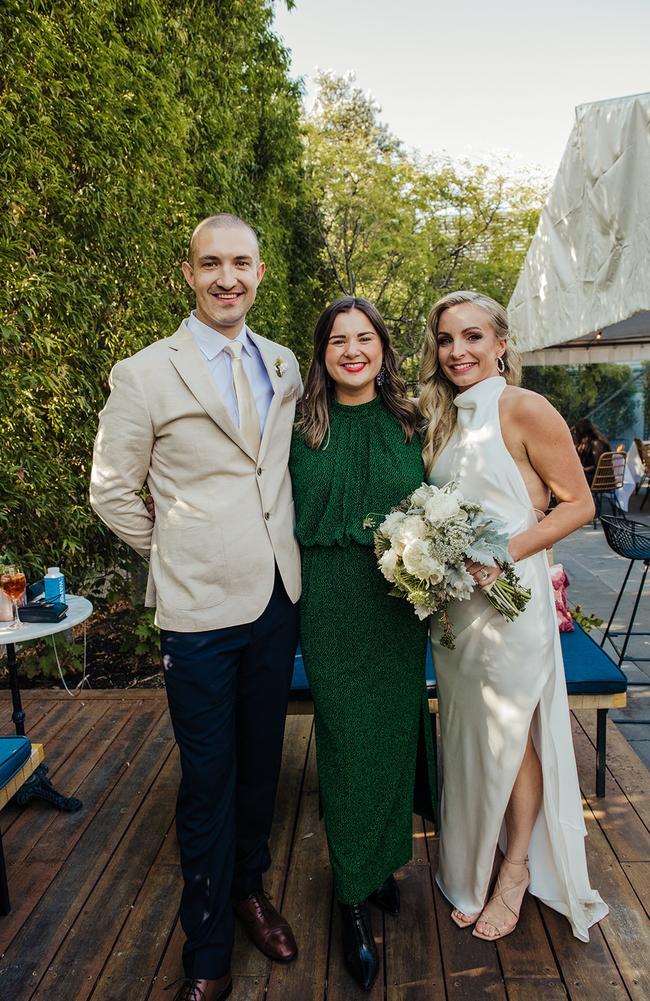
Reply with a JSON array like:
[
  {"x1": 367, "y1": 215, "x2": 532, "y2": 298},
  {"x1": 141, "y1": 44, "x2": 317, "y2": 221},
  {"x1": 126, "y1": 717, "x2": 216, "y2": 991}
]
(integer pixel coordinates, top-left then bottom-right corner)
[{"x1": 274, "y1": 0, "x2": 650, "y2": 178}]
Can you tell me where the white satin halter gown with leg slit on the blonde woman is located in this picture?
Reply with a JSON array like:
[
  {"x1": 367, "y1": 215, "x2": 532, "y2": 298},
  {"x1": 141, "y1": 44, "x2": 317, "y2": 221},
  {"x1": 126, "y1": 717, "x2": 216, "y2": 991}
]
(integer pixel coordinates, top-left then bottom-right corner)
[{"x1": 430, "y1": 376, "x2": 608, "y2": 942}]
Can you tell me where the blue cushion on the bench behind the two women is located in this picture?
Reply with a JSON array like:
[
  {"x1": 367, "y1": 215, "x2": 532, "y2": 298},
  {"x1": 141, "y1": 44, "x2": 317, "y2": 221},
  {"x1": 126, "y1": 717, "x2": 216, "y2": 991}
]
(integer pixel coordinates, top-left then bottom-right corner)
[{"x1": 291, "y1": 623, "x2": 627, "y2": 699}]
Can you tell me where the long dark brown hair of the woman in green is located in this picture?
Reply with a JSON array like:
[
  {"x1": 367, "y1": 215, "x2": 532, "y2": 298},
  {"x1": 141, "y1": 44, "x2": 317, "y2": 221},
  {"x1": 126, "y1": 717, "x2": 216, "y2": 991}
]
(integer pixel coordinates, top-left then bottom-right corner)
[{"x1": 295, "y1": 295, "x2": 418, "y2": 448}]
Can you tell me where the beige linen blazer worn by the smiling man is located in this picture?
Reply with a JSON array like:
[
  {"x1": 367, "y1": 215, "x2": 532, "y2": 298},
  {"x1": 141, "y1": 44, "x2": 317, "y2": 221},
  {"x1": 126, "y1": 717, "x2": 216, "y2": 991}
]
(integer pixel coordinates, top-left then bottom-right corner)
[{"x1": 90, "y1": 322, "x2": 301, "y2": 633}]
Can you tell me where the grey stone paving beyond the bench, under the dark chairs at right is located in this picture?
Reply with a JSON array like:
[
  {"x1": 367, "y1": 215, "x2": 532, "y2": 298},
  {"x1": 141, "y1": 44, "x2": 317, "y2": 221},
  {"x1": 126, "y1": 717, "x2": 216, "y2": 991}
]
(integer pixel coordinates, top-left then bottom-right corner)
[{"x1": 554, "y1": 495, "x2": 650, "y2": 768}]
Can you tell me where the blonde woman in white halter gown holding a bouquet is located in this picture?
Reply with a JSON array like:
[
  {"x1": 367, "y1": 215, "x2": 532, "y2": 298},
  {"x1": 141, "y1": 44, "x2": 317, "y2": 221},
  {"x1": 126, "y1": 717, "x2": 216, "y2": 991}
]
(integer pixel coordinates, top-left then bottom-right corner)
[{"x1": 420, "y1": 292, "x2": 607, "y2": 942}]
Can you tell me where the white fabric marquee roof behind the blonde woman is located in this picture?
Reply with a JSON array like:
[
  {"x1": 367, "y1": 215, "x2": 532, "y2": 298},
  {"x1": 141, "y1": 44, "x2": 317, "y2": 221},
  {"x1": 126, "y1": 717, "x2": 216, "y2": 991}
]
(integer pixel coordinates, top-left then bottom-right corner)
[{"x1": 508, "y1": 93, "x2": 650, "y2": 365}]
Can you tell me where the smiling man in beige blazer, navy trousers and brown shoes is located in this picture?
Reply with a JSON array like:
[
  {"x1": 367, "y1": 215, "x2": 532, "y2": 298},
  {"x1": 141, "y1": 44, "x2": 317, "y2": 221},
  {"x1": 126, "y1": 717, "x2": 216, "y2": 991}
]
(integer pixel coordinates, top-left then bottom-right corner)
[{"x1": 90, "y1": 214, "x2": 301, "y2": 1001}]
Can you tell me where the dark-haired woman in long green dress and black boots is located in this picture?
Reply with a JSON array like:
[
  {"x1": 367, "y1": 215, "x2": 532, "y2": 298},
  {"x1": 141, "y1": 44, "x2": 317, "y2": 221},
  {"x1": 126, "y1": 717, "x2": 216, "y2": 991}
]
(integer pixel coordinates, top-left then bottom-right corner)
[{"x1": 289, "y1": 296, "x2": 435, "y2": 990}]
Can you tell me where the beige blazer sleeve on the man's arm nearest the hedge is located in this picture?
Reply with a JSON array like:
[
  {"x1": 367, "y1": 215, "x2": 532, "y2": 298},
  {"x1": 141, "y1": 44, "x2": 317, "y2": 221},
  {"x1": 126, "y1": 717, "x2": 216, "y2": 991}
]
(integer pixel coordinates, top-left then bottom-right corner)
[{"x1": 90, "y1": 359, "x2": 154, "y2": 557}]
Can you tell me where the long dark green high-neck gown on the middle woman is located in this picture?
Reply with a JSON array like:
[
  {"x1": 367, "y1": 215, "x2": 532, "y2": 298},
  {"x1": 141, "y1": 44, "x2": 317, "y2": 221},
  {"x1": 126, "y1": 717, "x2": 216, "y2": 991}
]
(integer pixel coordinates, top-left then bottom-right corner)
[{"x1": 289, "y1": 396, "x2": 435, "y2": 904}]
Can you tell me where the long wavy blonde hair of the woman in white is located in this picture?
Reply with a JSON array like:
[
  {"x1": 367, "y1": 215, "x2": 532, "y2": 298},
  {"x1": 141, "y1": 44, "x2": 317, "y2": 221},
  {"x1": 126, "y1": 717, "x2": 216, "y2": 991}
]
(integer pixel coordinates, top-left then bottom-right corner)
[{"x1": 420, "y1": 290, "x2": 522, "y2": 472}]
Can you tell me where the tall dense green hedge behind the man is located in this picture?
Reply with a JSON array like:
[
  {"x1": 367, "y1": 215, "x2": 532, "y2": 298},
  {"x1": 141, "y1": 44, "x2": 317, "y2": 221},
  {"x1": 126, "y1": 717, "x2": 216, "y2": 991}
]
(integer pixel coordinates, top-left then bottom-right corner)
[{"x1": 0, "y1": 0, "x2": 321, "y2": 590}]
